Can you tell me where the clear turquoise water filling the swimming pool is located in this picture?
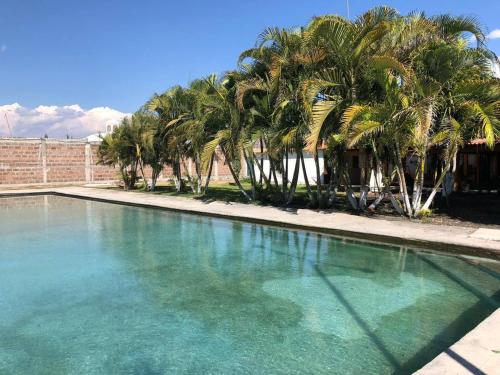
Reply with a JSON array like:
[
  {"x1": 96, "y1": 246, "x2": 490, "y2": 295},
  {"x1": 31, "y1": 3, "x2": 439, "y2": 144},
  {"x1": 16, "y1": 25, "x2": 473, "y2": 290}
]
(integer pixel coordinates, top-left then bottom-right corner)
[{"x1": 0, "y1": 196, "x2": 500, "y2": 375}]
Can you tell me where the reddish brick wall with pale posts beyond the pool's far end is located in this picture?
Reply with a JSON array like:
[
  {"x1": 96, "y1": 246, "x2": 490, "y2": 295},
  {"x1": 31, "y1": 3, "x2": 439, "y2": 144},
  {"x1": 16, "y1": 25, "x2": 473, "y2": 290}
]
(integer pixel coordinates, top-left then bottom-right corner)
[{"x1": 0, "y1": 138, "x2": 231, "y2": 185}]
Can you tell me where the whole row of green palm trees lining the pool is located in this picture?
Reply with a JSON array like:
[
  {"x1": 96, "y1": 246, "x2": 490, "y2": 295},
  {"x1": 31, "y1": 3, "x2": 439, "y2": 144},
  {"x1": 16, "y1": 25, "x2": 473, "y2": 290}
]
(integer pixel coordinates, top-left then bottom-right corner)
[{"x1": 100, "y1": 7, "x2": 500, "y2": 217}]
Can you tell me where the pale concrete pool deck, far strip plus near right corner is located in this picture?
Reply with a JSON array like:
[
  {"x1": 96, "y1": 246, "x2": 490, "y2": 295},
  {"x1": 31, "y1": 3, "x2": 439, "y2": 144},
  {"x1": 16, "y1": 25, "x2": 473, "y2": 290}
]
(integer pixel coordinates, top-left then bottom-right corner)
[{"x1": 0, "y1": 187, "x2": 500, "y2": 375}]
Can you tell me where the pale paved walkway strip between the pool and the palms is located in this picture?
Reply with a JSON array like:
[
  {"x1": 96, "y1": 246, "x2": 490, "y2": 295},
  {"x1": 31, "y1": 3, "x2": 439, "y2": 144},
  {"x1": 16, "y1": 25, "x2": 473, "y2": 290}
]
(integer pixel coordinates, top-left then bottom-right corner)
[{"x1": 0, "y1": 187, "x2": 500, "y2": 258}]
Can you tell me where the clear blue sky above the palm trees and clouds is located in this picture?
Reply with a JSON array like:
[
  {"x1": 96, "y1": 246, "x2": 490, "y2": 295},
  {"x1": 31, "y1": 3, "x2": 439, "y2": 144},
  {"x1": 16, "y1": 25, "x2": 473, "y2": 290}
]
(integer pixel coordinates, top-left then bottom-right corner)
[{"x1": 0, "y1": 0, "x2": 500, "y2": 138}]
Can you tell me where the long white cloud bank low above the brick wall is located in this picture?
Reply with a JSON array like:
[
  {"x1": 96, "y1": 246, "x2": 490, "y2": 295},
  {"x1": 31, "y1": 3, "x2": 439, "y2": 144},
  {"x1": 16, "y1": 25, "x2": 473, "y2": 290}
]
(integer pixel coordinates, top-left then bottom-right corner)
[{"x1": 0, "y1": 103, "x2": 130, "y2": 138}]
